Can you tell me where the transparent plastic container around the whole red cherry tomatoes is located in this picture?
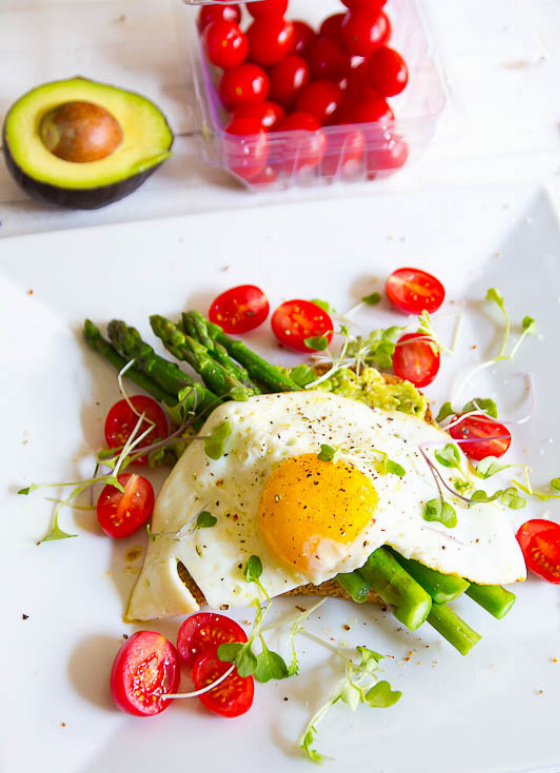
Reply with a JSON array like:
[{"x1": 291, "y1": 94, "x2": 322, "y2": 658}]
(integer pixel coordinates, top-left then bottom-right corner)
[{"x1": 185, "y1": 0, "x2": 446, "y2": 190}]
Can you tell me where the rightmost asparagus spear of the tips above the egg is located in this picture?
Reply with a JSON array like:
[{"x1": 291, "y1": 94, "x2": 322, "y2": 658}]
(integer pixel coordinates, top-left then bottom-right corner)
[{"x1": 183, "y1": 311, "x2": 300, "y2": 392}]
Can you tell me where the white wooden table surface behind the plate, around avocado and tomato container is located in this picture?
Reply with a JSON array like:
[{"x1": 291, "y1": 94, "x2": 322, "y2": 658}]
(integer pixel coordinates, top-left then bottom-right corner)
[{"x1": 0, "y1": 0, "x2": 560, "y2": 237}]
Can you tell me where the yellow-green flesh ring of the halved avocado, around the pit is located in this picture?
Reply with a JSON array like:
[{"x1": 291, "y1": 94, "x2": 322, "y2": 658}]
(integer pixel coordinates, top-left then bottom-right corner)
[{"x1": 4, "y1": 78, "x2": 173, "y2": 190}]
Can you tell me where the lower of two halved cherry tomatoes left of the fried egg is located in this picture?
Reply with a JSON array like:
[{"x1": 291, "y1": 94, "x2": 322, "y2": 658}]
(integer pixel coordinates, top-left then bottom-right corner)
[{"x1": 97, "y1": 472, "x2": 154, "y2": 539}]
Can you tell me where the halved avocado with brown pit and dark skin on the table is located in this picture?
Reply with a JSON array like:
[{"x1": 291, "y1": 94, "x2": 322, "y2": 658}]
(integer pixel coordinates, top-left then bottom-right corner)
[{"x1": 2, "y1": 77, "x2": 173, "y2": 209}]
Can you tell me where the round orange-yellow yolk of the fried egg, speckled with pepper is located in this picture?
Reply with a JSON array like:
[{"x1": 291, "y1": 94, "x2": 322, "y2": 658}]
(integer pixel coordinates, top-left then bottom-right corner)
[{"x1": 258, "y1": 454, "x2": 378, "y2": 576}]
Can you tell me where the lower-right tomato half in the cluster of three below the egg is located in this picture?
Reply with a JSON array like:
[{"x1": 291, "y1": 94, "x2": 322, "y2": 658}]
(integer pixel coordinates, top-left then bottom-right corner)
[{"x1": 192, "y1": 650, "x2": 255, "y2": 717}]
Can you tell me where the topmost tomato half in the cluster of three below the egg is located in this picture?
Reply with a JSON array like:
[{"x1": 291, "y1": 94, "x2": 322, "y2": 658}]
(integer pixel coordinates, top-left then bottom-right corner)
[{"x1": 177, "y1": 612, "x2": 247, "y2": 666}]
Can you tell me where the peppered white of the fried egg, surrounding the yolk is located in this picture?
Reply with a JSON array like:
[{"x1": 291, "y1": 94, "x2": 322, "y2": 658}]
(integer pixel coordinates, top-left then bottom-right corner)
[{"x1": 127, "y1": 391, "x2": 526, "y2": 620}]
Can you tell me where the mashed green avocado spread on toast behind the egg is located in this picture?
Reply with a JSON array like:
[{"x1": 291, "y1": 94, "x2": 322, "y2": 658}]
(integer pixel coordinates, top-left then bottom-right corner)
[{"x1": 290, "y1": 367, "x2": 428, "y2": 419}]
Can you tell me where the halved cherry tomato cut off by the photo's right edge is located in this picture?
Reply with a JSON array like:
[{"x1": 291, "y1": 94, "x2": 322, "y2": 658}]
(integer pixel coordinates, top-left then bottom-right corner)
[{"x1": 515, "y1": 518, "x2": 560, "y2": 585}]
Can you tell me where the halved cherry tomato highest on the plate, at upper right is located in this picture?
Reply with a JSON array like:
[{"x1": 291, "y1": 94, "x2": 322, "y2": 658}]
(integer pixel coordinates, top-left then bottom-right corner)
[{"x1": 385, "y1": 268, "x2": 445, "y2": 314}]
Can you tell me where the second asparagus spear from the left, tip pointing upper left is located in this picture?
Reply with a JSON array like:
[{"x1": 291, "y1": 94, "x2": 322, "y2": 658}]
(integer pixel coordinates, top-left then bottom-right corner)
[{"x1": 107, "y1": 319, "x2": 220, "y2": 414}]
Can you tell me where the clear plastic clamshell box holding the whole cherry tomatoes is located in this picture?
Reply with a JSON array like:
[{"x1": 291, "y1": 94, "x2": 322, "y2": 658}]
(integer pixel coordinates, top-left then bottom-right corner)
[{"x1": 184, "y1": 0, "x2": 447, "y2": 191}]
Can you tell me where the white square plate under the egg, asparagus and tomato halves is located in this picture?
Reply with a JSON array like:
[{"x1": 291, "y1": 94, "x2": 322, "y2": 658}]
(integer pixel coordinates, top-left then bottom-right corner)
[{"x1": 0, "y1": 186, "x2": 560, "y2": 773}]
